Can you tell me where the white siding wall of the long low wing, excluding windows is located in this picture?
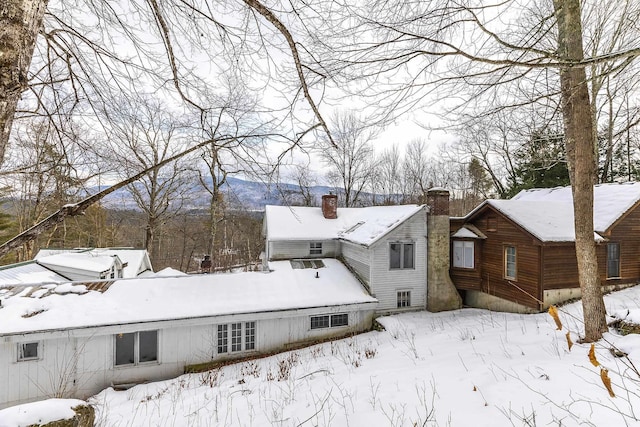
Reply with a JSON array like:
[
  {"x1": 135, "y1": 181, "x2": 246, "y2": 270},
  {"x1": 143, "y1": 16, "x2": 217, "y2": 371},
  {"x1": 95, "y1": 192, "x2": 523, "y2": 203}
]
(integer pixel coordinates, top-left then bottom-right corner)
[{"x1": 0, "y1": 303, "x2": 375, "y2": 409}]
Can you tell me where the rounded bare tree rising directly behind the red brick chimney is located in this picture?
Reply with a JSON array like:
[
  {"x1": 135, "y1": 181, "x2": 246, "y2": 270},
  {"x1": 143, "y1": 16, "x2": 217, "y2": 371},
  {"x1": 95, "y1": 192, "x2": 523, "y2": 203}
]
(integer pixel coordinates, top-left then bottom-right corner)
[{"x1": 320, "y1": 112, "x2": 376, "y2": 207}]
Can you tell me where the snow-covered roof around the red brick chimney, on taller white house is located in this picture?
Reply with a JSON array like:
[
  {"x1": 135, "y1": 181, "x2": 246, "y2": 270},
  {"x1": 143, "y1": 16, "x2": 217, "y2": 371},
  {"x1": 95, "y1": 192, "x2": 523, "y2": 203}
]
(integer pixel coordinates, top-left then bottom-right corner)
[{"x1": 265, "y1": 205, "x2": 424, "y2": 246}]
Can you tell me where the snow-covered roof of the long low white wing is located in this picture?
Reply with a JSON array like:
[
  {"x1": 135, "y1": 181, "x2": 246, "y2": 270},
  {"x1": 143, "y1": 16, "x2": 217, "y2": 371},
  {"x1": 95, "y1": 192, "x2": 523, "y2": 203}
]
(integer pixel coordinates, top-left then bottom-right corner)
[{"x1": 0, "y1": 259, "x2": 377, "y2": 336}]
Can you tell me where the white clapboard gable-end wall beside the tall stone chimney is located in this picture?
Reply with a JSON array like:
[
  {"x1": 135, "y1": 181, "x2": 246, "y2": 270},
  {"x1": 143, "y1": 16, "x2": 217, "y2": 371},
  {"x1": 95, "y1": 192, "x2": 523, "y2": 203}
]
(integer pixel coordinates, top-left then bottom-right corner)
[{"x1": 369, "y1": 211, "x2": 427, "y2": 313}]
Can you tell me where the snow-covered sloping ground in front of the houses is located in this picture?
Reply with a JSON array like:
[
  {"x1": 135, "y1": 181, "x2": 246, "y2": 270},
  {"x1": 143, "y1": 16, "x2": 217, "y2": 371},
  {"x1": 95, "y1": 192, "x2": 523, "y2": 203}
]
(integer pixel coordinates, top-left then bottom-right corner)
[{"x1": 6, "y1": 287, "x2": 640, "y2": 427}]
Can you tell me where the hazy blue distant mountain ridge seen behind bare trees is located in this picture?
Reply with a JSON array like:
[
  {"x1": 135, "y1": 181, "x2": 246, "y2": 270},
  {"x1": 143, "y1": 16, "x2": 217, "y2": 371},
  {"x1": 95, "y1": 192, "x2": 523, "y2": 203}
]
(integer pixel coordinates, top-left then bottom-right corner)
[{"x1": 101, "y1": 177, "x2": 341, "y2": 211}]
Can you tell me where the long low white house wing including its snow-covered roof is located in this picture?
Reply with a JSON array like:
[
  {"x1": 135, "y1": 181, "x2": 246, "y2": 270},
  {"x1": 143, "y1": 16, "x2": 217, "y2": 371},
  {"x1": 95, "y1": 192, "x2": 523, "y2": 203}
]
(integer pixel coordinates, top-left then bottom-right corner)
[{"x1": 0, "y1": 259, "x2": 378, "y2": 409}]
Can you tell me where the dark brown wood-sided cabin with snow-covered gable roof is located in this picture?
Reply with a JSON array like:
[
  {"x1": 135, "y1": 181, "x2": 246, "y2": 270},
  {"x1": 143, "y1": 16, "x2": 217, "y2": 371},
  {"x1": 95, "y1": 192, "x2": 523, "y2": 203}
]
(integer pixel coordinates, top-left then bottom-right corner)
[{"x1": 450, "y1": 183, "x2": 640, "y2": 311}]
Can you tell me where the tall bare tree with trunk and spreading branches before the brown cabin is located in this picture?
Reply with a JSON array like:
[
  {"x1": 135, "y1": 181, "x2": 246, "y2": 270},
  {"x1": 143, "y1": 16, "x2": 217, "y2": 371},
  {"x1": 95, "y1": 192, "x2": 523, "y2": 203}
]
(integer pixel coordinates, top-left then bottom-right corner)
[{"x1": 316, "y1": 0, "x2": 640, "y2": 341}]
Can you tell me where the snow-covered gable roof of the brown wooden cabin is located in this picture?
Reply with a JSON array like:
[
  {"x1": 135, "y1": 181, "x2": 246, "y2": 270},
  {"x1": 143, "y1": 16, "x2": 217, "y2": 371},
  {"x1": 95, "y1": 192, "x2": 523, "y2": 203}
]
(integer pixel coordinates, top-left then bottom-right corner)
[{"x1": 465, "y1": 182, "x2": 640, "y2": 242}]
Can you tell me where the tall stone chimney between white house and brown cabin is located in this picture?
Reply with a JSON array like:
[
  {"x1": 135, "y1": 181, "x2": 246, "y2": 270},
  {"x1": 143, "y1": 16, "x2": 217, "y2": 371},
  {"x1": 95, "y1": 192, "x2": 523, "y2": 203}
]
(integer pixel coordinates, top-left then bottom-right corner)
[{"x1": 427, "y1": 188, "x2": 462, "y2": 312}]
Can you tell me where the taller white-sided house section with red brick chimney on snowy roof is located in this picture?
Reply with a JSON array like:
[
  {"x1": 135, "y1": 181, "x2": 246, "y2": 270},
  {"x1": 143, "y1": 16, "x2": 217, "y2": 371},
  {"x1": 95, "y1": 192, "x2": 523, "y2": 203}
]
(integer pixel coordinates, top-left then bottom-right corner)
[{"x1": 263, "y1": 195, "x2": 428, "y2": 313}]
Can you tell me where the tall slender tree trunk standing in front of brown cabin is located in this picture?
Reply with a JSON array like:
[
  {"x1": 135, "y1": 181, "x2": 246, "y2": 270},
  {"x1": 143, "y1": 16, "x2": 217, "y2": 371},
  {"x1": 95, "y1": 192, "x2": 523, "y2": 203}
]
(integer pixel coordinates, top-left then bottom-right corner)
[{"x1": 553, "y1": 0, "x2": 607, "y2": 342}]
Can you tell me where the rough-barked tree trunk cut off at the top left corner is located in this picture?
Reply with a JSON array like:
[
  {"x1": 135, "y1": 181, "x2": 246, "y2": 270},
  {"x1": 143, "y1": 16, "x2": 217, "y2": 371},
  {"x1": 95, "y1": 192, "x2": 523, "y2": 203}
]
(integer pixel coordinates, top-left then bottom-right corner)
[{"x1": 0, "y1": 0, "x2": 47, "y2": 164}]
